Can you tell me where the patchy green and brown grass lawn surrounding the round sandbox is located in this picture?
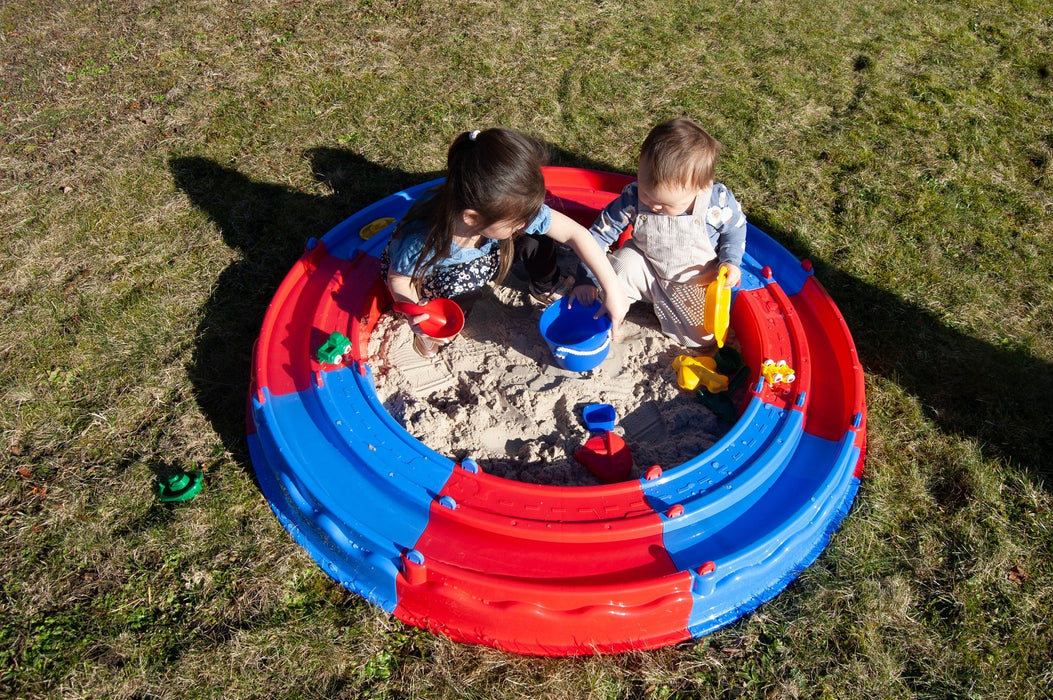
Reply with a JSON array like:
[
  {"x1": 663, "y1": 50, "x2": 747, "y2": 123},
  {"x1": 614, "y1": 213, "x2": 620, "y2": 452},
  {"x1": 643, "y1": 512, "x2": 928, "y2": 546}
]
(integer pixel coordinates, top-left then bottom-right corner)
[{"x1": 0, "y1": 0, "x2": 1053, "y2": 699}]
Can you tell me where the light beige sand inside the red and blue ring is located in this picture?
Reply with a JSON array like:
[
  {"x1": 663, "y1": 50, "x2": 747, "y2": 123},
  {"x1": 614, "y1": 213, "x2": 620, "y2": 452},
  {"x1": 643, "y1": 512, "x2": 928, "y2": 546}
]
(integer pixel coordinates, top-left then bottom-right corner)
[{"x1": 370, "y1": 262, "x2": 734, "y2": 486}]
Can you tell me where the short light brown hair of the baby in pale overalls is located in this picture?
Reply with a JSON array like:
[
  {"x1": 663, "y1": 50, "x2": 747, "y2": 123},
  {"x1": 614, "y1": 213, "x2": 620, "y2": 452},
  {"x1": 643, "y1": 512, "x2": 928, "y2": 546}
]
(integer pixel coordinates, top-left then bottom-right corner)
[{"x1": 640, "y1": 117, "x2": 720, "y2": 189}]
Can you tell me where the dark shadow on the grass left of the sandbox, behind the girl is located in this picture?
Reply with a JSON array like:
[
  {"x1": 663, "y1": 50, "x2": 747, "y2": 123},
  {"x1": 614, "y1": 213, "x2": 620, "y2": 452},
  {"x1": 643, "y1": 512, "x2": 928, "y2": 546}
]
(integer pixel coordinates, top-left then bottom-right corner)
[{"x1": 168, "y1": 148, "x2": 438, "y2": 465}]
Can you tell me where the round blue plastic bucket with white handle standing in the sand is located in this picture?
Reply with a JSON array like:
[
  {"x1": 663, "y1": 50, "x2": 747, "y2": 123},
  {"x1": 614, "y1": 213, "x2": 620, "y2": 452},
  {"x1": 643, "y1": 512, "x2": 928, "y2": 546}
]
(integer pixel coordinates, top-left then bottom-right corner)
[{"x1": 540, "y1": 297, "x2": 611, "y2": 372}]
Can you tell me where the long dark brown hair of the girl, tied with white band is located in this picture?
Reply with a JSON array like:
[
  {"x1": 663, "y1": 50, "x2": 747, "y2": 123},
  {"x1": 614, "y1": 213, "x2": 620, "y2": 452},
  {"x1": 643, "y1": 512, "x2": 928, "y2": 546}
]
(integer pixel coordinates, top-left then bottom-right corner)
[{"x1": 394, "y1": 127, "x2": 547, "y2": 285}]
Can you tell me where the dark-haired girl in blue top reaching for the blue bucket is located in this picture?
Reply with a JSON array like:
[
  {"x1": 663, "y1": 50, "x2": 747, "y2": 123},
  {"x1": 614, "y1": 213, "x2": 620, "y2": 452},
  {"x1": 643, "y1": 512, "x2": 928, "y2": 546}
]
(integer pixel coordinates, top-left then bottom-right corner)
[{"x1": 381, "y1": 128, "x2": 629, "y2": 357}]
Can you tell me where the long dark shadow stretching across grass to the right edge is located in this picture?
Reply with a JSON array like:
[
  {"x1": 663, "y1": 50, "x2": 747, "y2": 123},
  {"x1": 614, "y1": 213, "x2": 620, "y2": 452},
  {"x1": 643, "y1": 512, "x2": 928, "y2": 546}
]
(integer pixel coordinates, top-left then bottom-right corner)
[{"x1": 752, "y1": 211, "x2": 1053, "y2": 486}]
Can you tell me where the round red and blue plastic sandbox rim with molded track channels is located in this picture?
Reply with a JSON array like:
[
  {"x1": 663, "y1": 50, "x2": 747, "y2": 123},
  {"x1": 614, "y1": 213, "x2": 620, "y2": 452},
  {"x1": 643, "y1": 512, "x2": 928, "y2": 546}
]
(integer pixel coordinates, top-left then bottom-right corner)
[{"x1": 247, "y1": 167, "x2": 867, "y2": 656}]
